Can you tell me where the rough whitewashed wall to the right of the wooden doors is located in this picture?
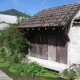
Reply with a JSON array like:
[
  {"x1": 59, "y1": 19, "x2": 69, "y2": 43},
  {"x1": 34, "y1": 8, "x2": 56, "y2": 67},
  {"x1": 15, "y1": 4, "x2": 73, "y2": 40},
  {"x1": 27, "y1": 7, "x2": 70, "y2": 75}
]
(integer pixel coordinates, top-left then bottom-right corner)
[{"x1": 68, "y1": 11, "x2": 80, "y2": 65}]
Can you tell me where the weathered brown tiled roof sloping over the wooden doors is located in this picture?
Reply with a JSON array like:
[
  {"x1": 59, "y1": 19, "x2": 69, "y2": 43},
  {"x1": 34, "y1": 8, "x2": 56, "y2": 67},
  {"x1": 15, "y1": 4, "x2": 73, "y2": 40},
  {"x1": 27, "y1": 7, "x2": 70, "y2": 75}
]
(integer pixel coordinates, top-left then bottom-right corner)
[{"x1": 19, "y1": 3, "x2": 80, "y2": 28}]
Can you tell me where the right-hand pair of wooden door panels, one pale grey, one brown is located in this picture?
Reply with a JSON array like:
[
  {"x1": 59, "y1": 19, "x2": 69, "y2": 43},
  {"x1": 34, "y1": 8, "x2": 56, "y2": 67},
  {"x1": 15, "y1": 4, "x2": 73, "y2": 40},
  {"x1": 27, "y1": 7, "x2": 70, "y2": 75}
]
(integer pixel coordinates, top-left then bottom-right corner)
[{"x1": 48, "y1": 31, "x2": 67, "y2": 64}]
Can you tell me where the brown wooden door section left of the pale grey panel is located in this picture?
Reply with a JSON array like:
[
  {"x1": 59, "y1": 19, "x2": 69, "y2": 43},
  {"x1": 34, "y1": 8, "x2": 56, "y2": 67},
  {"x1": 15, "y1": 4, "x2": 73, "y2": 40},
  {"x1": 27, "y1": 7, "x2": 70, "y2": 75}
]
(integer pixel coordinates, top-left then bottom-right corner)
[{"x1": 29, "y1": 31, "x2": 48, "y2": 59}]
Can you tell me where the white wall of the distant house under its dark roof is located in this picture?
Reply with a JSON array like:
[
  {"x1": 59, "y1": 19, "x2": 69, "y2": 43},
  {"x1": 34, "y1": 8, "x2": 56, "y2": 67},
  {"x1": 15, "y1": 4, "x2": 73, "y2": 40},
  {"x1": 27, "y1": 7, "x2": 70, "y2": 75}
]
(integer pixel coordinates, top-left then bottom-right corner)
[{"x1": 0, "y1": 14, "x2": 17, "y2": 23}]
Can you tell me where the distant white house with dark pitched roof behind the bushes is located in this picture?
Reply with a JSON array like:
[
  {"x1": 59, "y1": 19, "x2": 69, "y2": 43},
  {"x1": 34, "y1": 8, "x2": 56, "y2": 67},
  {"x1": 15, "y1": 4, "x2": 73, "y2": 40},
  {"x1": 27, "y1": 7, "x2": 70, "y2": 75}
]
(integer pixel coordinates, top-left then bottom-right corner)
[{"x1": 0, "y1": 9, "x2": 28, "y2": 30}]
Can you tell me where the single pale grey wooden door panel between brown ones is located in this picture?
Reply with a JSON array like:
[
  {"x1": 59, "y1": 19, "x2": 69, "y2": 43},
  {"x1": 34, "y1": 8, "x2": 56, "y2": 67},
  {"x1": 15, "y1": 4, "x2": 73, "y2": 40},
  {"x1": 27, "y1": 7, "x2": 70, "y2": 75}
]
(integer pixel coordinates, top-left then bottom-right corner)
[{"x1": 48, "y1": 33, "x2": 56, "y2": 61}]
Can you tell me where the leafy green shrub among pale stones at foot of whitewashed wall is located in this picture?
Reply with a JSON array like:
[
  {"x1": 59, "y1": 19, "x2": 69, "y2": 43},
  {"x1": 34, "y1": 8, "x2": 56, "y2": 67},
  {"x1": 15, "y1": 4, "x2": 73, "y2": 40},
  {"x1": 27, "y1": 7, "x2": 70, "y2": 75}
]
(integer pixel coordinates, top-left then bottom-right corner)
[{"x1": 60, "y1": 64, "x2": 80, "y2": 80}]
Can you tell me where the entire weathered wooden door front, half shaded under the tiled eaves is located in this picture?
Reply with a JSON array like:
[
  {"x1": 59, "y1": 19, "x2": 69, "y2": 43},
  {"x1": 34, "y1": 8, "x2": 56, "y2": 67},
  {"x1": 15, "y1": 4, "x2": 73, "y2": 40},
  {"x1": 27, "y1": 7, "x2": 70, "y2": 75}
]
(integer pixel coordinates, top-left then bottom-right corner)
[{"x1": 30, "y1": 31, "x2": 67, "y2": 64}]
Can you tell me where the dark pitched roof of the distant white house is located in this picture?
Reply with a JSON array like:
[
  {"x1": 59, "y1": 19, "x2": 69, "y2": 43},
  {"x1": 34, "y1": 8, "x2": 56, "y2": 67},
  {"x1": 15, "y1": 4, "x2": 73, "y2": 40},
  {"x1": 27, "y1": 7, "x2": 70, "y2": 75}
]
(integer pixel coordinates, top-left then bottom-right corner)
[{"x1": 0, "y1": 9, "x2": 26, "y2": 16}]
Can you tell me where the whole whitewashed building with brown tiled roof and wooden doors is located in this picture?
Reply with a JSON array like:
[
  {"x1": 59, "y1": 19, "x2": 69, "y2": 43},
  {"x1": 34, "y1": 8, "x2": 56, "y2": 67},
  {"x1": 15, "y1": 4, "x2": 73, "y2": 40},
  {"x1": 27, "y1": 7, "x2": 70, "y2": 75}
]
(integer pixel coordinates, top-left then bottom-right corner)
[{"x1": 19, "y1": 3, "x2": 80, "y2": 71}]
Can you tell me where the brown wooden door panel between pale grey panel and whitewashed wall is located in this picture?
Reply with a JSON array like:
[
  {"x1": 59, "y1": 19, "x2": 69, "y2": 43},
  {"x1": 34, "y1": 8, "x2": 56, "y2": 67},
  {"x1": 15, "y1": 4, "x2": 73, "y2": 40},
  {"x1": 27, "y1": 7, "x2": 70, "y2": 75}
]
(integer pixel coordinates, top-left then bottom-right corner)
[{"x1": 56, "y1": 33, "x2": 67, "y2": 64}]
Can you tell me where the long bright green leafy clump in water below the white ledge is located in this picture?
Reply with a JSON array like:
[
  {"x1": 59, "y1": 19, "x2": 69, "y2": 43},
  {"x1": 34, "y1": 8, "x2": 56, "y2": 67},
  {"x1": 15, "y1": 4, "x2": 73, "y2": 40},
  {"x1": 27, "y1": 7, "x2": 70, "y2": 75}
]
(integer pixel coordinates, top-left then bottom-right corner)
[{"x1": 9, "y1": 63, "x2": 59, "y2": 79}]
